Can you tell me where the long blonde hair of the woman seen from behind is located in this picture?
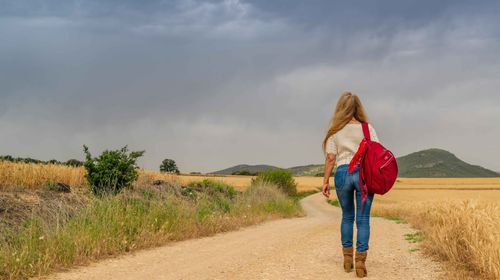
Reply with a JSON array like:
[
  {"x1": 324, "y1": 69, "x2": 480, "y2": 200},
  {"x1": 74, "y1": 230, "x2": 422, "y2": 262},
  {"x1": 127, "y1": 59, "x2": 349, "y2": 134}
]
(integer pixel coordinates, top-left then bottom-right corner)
[{"x1": 323, "y1": 92, "x2": 368, "y2": 152}]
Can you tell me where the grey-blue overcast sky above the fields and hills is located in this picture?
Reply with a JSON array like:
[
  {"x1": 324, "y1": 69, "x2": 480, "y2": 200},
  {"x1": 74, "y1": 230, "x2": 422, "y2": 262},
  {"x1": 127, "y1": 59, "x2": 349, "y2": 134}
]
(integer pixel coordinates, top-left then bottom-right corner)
[{"x1": 0, "y1": 0, "x2": 500, "y2": 172}]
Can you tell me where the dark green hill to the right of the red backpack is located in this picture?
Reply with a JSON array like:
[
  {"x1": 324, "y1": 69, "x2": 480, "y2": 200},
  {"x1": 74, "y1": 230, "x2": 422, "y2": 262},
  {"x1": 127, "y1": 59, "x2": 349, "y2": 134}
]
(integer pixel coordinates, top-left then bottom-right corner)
[{"x1": 397, "y1": 149, "x2": 500, "y2": 178}]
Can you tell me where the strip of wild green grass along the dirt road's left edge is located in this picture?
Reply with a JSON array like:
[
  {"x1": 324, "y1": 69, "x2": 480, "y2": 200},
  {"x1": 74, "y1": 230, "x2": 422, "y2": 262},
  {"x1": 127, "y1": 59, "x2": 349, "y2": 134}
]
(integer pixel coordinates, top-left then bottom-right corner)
[{"x1": 0, "y1": 182, "x2": 302, "y2": 279}]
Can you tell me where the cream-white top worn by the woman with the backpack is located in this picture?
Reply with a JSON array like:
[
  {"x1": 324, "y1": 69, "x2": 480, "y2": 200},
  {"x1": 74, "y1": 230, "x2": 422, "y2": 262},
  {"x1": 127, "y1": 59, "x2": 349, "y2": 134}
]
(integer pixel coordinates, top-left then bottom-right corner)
[{"x1": 326, "y1": 123, "x2": 379, "y2": 167}]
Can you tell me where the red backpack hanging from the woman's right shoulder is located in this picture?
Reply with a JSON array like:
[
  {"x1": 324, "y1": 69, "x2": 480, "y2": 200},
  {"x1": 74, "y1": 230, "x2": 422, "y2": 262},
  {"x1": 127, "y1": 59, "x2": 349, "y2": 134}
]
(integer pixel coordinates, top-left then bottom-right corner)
[{"x1": 349, "y1": 122, "x2": 398, "y2": 209}]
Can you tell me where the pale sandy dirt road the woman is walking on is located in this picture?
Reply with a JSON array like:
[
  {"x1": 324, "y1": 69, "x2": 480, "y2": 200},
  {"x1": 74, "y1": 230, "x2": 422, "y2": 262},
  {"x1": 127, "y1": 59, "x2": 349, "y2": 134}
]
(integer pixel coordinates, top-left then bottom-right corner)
[{"x1": 43, "y1": 193, "x2": 440, "y2": 280}]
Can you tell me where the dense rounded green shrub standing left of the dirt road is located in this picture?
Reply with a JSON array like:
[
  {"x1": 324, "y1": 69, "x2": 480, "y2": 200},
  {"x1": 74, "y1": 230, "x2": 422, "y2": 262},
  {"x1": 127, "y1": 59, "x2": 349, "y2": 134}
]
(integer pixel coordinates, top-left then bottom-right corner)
[{"x1": 83, "y1": 145, "x2": 144, "y2": 196}]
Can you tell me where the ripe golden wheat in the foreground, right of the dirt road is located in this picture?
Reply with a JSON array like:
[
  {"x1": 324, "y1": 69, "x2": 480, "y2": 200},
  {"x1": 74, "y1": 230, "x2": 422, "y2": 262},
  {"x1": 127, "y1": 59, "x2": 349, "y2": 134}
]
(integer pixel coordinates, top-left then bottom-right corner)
[{"x1": 372, "y1": 199, "x2": 500, "y2": 279}]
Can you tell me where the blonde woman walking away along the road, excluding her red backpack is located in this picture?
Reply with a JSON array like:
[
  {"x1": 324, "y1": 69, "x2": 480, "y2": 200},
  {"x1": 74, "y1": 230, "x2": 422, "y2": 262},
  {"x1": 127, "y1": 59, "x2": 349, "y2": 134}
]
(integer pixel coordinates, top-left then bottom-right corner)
[{"x1": 322, "y1": 92, "x2": 379, "y2": 277}]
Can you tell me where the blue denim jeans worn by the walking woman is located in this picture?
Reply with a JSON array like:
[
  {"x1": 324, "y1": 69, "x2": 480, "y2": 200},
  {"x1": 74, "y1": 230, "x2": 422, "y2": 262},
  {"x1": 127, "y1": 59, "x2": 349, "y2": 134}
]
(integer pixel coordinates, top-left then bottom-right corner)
[{"x1": 334, "y1": 164, "x2": 373, "y2": 252}]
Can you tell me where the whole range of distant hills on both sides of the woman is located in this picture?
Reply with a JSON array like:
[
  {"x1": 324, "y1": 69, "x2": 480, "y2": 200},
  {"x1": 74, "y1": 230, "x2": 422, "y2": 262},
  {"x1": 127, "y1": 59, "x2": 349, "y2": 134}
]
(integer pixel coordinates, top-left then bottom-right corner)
[{"x1": 213, "y1": 149, "x2": 500, "y2": 178}]
